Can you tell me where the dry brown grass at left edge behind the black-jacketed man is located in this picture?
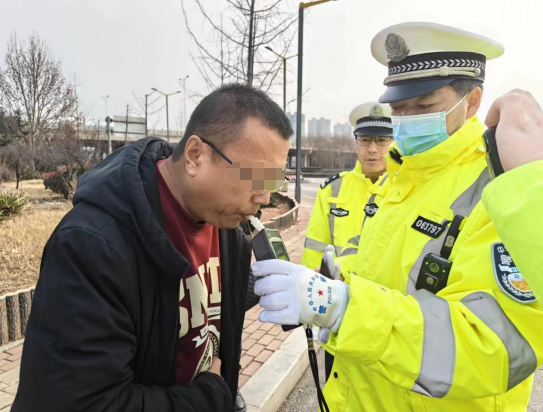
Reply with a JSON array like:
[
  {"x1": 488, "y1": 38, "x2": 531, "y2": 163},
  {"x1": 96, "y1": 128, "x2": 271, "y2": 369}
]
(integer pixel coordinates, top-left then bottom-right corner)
[{"x1": 0, "y1": 180, "x2": 72, "y2": 296}]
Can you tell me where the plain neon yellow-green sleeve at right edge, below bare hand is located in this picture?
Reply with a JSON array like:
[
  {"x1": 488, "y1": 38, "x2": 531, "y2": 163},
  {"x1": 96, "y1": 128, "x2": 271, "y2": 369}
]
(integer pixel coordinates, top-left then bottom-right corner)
[{"x1": 483, "y1": 160, "x2": 543, "y2": 302}]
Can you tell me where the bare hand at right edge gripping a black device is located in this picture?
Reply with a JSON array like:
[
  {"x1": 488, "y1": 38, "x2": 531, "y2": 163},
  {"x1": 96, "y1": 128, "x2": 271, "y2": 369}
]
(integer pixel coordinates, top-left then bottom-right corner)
[{"x1": 485, "y1": 90, "x2": 543, "y2": 172}]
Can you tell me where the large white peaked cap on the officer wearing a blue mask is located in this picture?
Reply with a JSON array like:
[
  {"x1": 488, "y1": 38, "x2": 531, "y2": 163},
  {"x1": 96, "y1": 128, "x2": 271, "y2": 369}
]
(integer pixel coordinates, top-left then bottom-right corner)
[{"x1": 371, "y1": 23, "x2": 504, "y2": 103}]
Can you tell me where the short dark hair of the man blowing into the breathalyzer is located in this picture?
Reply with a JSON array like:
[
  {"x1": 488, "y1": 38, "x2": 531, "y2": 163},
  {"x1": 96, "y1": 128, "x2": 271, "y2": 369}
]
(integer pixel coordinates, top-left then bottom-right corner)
[{"x1": 173, "y1": 84, "x2": 293, "y2": 161}]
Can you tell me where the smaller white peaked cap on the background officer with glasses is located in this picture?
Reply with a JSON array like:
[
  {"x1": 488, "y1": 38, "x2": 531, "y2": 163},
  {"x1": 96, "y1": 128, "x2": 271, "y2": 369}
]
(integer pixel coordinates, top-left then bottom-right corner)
[{"x1": 349, "y1": 102, "x2": 392, "y2": 136}]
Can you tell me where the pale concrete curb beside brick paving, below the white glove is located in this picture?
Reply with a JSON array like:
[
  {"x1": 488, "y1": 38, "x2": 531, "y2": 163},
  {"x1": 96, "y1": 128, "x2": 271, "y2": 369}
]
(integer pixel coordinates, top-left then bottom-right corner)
[{"x1": 241, "y1": 327, "x2": 320, "y2": 412}]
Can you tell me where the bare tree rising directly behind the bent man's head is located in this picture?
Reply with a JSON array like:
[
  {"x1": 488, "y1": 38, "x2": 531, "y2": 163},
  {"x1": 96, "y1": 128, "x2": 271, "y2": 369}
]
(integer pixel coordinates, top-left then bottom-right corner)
[{"x1": 181, "y1": 0, "x2": 297, "y2": 92}]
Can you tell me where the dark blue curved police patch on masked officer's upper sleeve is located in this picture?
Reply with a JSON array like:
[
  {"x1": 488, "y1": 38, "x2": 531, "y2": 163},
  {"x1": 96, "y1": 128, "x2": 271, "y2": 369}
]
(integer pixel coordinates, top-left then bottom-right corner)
[{"x1": 492, "y1": 242, "x2": 536, "y2": 303}]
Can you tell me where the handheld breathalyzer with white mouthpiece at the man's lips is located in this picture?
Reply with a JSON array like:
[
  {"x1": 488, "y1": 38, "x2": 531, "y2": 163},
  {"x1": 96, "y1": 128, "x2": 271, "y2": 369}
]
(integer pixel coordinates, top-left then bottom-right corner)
[{"x1": 249, "y1": 216, "x2": 301, "y2": 331}]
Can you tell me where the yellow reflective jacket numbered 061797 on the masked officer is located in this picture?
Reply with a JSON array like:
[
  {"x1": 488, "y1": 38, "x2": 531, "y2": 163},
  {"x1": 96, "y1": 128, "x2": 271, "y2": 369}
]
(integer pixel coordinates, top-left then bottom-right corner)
[{"x1": 324, "y1": 119, "x2": 543, "y2": 412}]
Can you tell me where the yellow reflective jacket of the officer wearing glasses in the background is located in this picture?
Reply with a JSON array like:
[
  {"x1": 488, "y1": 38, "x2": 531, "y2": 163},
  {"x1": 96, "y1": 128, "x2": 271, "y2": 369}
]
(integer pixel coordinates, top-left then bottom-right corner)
[{"x1": 302, "y1": 162, "x2": 387, "y2": 279}]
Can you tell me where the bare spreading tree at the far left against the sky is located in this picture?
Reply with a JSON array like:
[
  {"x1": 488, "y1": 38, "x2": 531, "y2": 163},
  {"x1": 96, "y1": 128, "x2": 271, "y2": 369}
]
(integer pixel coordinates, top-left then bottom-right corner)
[{"x1": 0, "y1": 34, "x2": 78, "y2": 152}]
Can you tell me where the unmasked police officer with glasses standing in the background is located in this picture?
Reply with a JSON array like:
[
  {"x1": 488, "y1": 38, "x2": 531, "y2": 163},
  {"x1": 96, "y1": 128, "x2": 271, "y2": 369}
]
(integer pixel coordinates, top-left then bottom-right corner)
[{"x1": 302, "y1": 102, "x2": 392, "y2": 379}]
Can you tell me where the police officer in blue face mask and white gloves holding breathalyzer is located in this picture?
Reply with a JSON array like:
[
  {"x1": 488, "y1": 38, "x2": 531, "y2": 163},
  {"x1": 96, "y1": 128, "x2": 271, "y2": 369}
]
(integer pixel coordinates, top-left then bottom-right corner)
[{"x1": 253, "y1": 23, "x2": 543, "y2": 411}]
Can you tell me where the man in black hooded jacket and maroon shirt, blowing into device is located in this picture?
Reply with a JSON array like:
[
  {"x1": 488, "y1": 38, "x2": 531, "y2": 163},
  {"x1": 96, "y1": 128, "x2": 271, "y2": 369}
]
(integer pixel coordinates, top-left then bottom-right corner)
[{"x1": 12, "y1": 85, "x2": 292, "y2": 412}]
